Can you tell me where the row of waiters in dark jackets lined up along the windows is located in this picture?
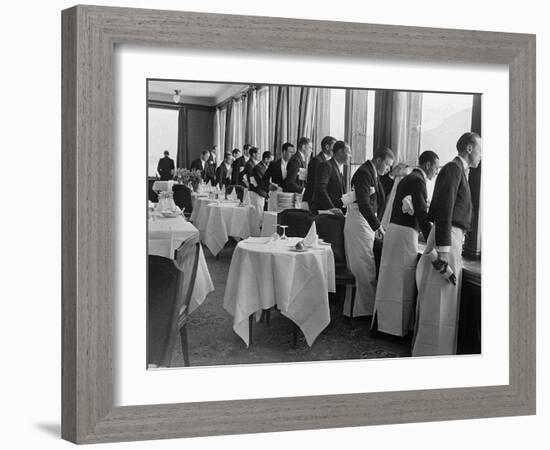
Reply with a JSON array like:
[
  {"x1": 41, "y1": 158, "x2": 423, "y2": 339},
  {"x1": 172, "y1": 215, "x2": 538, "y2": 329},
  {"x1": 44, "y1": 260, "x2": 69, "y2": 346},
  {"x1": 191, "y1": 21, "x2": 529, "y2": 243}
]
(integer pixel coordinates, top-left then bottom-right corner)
[{"x1": 190, "y1": 132, "x2": 481, "y2": 356}]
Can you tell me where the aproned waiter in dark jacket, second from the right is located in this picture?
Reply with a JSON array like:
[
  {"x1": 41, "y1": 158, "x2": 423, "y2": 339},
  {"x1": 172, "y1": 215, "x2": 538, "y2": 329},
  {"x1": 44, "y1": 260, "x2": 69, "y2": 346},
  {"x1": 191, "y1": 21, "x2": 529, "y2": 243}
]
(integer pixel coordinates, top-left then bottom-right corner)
[{"x1": 372, "y1": 150, "x2": 439, "y2": 337}]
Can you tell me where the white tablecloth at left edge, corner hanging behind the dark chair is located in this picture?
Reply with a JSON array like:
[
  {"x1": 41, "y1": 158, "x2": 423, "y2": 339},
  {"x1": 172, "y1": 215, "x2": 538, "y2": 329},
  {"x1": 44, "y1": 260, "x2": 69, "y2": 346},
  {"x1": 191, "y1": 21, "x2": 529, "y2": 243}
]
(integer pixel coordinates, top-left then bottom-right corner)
[{"x1": 148, "y1": 216, "x2": 214, "y2": 313}]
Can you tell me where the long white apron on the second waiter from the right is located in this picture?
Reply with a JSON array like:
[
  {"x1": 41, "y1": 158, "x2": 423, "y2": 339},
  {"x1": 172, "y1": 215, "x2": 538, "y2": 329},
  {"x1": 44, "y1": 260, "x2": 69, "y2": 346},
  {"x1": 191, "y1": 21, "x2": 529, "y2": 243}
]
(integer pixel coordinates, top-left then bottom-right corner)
[{"x1": 372, "y1": 223, "x2": 418, "y2": 336}]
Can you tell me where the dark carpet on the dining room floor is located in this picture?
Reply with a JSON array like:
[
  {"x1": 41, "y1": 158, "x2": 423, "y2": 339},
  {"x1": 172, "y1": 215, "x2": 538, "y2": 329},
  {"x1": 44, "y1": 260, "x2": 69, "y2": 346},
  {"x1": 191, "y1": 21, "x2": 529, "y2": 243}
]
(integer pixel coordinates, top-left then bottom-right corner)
[{"x1": 149, "y1": 241, "x2": 410, "y2": 367}]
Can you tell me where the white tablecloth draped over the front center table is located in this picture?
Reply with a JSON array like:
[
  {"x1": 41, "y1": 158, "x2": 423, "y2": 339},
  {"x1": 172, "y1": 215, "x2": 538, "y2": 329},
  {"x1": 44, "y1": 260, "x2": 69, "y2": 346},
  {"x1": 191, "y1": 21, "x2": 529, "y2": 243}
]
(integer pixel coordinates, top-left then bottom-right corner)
[{"x1": 223, "y1": 238, "x2": 336, "y2": 346}]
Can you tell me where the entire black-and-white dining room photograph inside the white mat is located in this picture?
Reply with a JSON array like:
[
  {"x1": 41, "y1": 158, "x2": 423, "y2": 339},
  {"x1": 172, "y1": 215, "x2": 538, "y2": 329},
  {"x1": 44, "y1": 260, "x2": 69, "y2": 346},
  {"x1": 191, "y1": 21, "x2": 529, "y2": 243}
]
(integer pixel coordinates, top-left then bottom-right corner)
[{"x1": 144, "y1": 79, "x2": 482, "y2": 369}]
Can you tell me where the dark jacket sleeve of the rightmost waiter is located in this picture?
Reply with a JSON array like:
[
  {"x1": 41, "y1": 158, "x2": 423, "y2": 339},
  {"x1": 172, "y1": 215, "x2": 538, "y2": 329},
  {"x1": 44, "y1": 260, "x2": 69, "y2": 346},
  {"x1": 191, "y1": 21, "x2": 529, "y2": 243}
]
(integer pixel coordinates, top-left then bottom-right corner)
[{"x1": 430, "y1": 164, "x2": 462, "y2": 247}]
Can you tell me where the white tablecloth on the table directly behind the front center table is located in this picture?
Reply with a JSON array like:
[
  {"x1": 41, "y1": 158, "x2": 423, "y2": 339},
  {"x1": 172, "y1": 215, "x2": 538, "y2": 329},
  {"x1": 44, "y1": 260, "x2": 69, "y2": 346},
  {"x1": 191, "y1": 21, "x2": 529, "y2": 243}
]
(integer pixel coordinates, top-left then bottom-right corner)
[{"x1": 198, "y1": 202, "x2": 260, "y2": 255}]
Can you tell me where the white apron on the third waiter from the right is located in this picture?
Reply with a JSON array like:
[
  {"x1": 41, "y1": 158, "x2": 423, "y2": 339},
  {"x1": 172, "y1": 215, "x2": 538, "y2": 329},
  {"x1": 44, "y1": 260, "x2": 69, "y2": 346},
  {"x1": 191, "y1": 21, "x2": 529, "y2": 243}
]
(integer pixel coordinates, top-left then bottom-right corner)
[{"x1": 344, "y1": 203, "x2": 376, "y2": 317}]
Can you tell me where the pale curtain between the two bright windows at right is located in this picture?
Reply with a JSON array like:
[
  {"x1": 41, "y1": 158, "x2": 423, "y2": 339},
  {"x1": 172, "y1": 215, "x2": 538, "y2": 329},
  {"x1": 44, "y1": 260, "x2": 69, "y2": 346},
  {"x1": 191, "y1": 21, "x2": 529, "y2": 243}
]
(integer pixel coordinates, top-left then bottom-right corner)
[{"x1": 374, "y1": 91, "x2": 422, "y2": 165}]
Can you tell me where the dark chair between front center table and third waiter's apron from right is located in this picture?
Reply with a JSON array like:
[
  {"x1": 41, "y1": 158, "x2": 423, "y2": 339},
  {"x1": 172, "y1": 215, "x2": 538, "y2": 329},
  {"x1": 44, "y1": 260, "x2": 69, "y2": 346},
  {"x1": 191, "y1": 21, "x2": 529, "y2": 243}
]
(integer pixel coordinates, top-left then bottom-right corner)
[{"x1": 315, "y1": 214, "x2": 356, "y2": 321}]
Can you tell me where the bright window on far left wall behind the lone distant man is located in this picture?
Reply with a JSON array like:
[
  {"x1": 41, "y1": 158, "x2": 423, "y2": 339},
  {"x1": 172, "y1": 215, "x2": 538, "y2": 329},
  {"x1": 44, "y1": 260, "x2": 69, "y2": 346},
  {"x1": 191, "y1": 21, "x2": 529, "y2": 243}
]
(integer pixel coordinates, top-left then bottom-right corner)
[{"x1": 147, "y1": 108, "x2": 178, "y2": 176}]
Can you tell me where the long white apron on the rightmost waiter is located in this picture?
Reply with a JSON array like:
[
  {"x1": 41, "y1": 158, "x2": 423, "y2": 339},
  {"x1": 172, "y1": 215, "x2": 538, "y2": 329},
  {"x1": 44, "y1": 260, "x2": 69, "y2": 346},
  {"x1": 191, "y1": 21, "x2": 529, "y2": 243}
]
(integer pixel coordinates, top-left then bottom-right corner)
[{"x1": 412, "y1": 226, "x2": 464, "y2": 356}]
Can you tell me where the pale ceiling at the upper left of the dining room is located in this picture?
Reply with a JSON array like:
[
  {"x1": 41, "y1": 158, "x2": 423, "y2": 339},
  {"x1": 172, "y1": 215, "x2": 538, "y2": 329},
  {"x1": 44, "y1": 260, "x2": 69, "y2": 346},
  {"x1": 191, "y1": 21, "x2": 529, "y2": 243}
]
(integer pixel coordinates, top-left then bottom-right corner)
[{"x1": 148, "y1": 80, "x2": 247, "y2": 105}]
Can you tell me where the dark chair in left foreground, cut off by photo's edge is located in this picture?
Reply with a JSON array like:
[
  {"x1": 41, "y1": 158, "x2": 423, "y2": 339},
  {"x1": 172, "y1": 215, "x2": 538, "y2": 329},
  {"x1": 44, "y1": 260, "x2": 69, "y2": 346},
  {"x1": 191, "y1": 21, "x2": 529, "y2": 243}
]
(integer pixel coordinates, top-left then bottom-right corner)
[{"x1": 147, "y1": 236, "x2": 200, "y2": 367}]
